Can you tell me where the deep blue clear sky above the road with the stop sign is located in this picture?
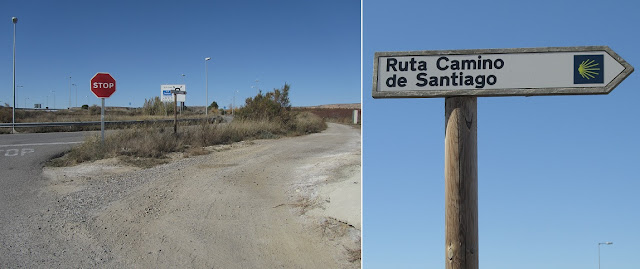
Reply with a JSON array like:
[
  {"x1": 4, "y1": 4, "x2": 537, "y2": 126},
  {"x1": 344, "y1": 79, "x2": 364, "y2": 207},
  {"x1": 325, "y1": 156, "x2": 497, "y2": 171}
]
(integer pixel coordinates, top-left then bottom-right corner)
[{"x1": 0, "y1": 0, "x2": 360, "y2": 108}]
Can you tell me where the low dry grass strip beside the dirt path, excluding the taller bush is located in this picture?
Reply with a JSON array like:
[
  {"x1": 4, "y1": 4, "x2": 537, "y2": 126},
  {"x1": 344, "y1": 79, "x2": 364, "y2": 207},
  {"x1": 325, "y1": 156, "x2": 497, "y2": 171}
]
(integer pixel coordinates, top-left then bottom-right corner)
[{"x1": 48, "y1": 110, "x2": 326, "y2": 167}]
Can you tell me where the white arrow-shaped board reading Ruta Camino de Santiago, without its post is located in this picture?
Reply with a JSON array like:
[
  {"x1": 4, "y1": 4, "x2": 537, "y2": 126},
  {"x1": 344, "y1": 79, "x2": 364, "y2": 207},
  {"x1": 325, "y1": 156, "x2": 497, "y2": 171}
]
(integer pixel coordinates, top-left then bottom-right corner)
[{"x1": 372, "y1": 46, "x2": 633, "y2": 98}]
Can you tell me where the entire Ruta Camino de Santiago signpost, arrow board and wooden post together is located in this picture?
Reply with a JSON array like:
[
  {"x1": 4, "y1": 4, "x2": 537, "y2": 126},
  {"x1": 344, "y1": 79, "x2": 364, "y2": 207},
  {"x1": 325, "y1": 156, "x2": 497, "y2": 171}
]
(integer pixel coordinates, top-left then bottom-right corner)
[{"x1": 372, "y1": 46, "x2": 633, "y2": 269}]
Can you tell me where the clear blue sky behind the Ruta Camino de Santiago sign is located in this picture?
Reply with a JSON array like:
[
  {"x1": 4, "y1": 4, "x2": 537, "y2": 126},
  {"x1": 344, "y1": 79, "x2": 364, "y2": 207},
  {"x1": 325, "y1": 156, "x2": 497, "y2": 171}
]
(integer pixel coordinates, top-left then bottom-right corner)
[{"x1": 363, "y1": 0, "x2": 640, "y2": 269}]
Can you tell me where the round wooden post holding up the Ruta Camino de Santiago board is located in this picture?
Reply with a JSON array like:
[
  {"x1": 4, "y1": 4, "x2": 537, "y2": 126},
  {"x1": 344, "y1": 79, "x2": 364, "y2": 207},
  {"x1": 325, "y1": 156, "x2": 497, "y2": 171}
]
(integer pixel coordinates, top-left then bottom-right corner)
[{"x1": 444, "y1": 97, "x2": 478, "y2": 269}]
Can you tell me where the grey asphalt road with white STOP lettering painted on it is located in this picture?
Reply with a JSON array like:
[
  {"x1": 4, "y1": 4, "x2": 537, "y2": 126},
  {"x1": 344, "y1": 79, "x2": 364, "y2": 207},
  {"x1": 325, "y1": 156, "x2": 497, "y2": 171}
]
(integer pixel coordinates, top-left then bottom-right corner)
[{"x1": 0, "y1": 132, "x2": 93, "y2": 268}]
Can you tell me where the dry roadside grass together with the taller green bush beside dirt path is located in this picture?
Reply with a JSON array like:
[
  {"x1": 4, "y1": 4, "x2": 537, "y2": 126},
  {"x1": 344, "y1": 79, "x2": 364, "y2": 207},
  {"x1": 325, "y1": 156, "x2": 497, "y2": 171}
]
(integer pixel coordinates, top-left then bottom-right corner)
[{"x1": 48, "y1": 84, "x2": 327, "y2": 167}]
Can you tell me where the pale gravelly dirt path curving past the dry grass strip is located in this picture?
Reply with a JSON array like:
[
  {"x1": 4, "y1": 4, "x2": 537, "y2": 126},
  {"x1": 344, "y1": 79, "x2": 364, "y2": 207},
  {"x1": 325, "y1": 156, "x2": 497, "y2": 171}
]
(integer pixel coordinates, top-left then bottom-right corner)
[{"x1": 40, "y1": 124, "x2": 361, "y2": 268}]
